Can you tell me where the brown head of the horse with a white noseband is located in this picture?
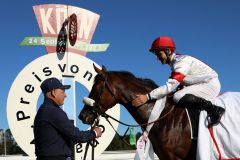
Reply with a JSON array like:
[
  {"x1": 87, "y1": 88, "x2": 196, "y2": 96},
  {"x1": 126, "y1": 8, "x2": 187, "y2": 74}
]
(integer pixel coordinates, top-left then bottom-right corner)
[{"x1": 78, "y1": 65, "x2": 117, "y2": 124}]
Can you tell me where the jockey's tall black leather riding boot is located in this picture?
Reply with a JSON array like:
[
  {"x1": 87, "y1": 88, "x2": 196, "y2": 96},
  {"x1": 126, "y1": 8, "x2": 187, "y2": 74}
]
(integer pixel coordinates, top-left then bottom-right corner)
[{"x1": 178, "y1": 94, "x2": 225, "y2": 127}]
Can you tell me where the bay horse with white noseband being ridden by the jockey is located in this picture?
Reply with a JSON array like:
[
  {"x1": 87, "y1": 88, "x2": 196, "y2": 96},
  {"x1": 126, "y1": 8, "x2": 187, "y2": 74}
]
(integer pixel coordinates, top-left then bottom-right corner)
[{"x1": 79, "y1": 65, "x2": 197, "y2": 160}]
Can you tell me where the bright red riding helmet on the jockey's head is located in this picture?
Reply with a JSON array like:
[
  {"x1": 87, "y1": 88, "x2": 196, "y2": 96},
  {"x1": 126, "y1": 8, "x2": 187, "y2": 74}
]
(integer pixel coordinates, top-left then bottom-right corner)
[{"x1": 149, "y1": 36, "x2": 176, "y2": 52}]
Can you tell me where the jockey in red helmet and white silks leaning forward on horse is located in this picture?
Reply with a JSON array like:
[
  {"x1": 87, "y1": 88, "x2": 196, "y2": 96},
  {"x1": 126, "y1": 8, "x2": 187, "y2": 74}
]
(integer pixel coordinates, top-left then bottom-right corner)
[{"x1": 132, "y1": 36, "x2": 225, "y2": 127}]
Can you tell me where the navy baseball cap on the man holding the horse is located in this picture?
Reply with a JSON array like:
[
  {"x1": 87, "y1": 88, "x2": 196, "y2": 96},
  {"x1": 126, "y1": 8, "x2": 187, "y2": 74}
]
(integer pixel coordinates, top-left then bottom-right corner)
[{"x1": 40, "y1": 77, "x2": 71, "y2": 94}]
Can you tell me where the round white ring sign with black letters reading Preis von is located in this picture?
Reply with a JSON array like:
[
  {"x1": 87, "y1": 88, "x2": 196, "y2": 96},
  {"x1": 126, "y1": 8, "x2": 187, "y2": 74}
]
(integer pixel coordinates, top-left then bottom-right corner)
[{"x1": 7, "y1": 53, "x2": 120, "y2": 160}]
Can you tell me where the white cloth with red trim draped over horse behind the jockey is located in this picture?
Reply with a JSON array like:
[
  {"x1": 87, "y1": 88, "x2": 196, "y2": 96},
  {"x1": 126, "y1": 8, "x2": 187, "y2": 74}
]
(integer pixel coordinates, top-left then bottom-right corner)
[{"x1": 197, "y1": 92, "x2": 240, "y2": 160}]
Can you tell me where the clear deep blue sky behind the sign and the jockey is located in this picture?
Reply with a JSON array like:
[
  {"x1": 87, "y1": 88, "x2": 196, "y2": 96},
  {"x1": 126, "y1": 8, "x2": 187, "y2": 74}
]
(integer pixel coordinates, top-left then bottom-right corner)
[{"x1": 0, "y1": 0, "x2": 240, "y2": 135}]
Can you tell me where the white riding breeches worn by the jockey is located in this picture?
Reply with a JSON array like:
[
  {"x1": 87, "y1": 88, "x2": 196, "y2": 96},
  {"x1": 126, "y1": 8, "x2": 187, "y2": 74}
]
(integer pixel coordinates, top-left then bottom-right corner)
[{"x1": 173, "y1": 78, "x2": 221, "y2": 103}]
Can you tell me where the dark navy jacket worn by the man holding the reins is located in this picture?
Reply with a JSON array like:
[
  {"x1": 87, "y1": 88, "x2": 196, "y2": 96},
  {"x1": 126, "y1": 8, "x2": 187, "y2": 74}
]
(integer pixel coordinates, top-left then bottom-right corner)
[{"x1": 34, "y1": 98, "x2": 96, "y2": 157}]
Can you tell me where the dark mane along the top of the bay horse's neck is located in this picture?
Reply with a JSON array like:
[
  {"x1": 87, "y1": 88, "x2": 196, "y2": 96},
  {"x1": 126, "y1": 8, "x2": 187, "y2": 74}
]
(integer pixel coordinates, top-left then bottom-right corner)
[{"x1": 108, "y1": 71, "x2": 158, "y2": 88}]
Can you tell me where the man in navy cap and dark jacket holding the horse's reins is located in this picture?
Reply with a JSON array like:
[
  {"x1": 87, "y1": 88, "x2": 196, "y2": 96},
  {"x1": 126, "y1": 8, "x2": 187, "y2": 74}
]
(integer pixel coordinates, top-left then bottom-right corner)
[{"x1": 34, "y1": 78, "x2": 102, "y2": 160}]
